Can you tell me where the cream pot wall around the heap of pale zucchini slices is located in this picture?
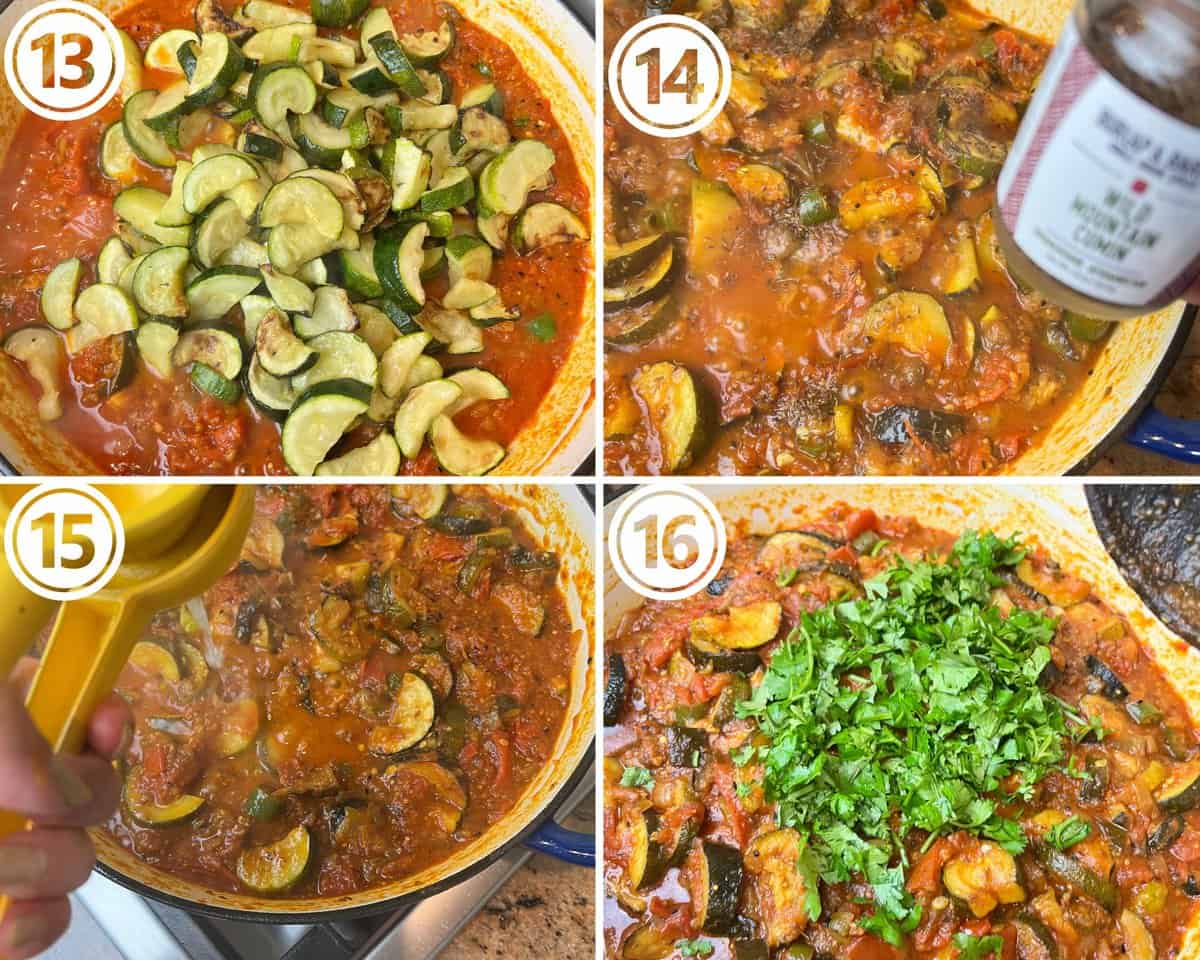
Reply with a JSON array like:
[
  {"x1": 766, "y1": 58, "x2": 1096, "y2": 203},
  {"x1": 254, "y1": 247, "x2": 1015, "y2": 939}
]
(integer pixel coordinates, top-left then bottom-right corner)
[{"x1": 0, "y1": 0, "x2": 599, "y2": 476}]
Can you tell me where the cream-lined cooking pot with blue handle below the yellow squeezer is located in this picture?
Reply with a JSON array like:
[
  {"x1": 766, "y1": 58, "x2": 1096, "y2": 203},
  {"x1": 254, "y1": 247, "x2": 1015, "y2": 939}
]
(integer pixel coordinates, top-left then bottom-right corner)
[{"x1": 91, "y1": 485, "x2": 595, "y2": 923}]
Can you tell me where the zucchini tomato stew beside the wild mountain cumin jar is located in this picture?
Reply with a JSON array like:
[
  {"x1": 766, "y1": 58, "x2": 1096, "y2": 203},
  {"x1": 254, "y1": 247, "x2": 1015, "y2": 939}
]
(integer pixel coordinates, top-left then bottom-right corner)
[{"x1": 605, "y1": 0, "x2": 1108, "y2": 474}]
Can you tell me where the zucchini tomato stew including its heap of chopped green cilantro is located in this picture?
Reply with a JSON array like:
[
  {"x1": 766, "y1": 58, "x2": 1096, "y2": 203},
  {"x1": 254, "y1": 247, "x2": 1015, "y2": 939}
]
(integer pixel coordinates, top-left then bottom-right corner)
[{"x1": 605, "y1": 508, "x2": 1200, "y2": 960}]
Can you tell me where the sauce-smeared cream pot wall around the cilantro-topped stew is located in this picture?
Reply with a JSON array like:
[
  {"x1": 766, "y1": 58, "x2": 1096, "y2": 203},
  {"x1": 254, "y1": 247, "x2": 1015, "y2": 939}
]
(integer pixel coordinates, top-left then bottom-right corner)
[{"x1": 604, "y1": 482, "x2": 1200, "y2": 960}]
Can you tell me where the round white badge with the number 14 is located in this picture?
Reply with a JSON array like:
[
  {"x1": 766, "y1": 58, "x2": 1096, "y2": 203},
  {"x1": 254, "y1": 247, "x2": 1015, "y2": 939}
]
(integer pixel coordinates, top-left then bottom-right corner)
[{"x1": 608, "y1": 13, "x2": 733, "y2": 138}]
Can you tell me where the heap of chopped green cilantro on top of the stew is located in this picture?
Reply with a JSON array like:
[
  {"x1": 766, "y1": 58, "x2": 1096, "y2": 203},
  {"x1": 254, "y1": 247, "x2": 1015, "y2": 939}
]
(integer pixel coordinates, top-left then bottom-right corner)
[{"x1": 733, "y1": 532, "x2": 1069, "y2": 946}]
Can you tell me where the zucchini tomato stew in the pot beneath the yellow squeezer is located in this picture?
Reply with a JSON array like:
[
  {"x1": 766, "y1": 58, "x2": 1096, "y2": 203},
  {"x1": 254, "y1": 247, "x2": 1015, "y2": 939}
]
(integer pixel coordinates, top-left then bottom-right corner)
[{"x1": 108, "y1": 486, "x2": 575, "y2": 896}]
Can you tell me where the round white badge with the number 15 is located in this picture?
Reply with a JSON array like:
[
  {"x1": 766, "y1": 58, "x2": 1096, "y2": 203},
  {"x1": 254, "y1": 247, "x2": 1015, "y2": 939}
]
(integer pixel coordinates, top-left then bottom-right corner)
[{"x1": 4, "y1": 484, "x2": 125, "y2": 600}]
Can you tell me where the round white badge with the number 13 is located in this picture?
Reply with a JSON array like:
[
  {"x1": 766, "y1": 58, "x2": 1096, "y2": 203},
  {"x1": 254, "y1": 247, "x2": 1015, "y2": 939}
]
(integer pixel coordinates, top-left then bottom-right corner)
[{"x1": 4, "y1": 0, "x2": 125, "y2": 120}]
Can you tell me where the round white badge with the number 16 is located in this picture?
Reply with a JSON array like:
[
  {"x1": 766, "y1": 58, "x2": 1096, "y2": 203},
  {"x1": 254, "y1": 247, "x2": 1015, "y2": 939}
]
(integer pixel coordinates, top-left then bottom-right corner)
[{"x1": 608, "y1": 482, "x2": 725, "y2": 600}]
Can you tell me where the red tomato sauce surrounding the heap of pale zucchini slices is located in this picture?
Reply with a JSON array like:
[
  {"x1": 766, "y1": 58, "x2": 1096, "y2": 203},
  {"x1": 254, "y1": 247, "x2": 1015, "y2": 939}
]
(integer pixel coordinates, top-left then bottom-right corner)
[{"x1": 0, "y1": 0, "x2": 592, "y2": 475}]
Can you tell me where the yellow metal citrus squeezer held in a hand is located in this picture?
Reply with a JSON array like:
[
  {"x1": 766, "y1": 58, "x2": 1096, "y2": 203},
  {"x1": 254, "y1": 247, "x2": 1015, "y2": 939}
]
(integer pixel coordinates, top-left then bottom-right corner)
[{"x1": 0, "y1": 484, "x2": 254, "y2": 919}]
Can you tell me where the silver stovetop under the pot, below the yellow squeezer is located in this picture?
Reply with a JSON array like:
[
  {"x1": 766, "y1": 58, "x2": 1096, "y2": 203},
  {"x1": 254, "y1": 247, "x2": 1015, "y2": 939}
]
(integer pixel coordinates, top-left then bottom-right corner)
[{"x1": 52, "y1": 767, "x2": 594, "y2": 960}]
